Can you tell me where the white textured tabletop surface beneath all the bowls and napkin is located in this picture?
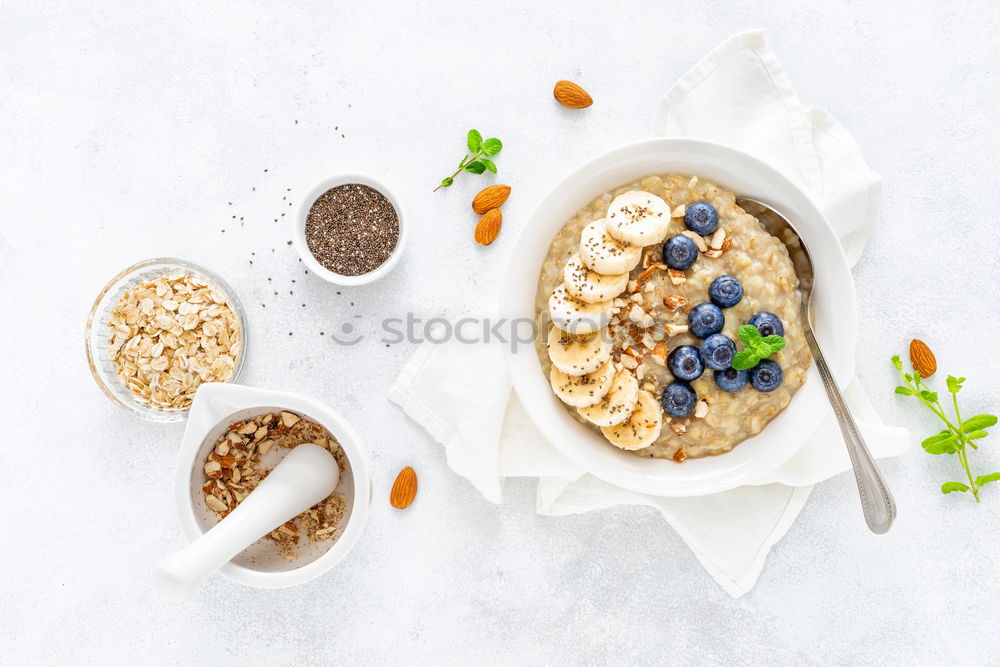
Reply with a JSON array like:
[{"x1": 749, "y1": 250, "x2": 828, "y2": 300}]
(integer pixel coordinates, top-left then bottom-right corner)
[{"x1": 0, "y1": 0, "x2": 1000, "y2": 664}]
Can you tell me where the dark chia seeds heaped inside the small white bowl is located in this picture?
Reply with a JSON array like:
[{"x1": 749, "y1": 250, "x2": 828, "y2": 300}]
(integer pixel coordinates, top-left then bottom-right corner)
[{"x1": 306, "y1": 183, "x2": 399, "y2": 276}]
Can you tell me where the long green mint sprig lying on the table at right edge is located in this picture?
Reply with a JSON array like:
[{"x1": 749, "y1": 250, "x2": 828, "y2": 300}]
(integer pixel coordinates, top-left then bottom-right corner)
[{"x1": 892, "y1": 354, "x2": 1000, "y2": 503}]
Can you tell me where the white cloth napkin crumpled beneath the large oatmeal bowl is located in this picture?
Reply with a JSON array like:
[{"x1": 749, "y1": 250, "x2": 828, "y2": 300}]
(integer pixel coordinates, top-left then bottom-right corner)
[{"x1": 389, "y1": 32, "x2": 909, "y2": 597}]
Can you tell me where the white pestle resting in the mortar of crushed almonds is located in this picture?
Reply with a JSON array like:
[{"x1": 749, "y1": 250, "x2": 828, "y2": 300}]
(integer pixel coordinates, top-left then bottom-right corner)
[{"x1": 153, "y1": 444, "x2": 340, "y2": 600}]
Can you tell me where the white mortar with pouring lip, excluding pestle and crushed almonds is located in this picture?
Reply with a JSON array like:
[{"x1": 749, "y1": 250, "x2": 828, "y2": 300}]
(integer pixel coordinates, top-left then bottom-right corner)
[{"x1": 168, "y1": 383, "x2": 372, "y2": 588}]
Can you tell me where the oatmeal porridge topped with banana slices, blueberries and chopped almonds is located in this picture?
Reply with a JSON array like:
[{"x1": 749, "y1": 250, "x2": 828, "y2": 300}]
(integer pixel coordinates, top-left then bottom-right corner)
[{"x1": 535, "y1": 174, "x2": 811, "y2": 462}]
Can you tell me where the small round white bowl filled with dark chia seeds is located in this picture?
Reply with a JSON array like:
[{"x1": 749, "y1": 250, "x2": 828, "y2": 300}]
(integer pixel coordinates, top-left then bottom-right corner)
[{"x1": 295, "y1": 173, "x2": 406, "y2": 286}]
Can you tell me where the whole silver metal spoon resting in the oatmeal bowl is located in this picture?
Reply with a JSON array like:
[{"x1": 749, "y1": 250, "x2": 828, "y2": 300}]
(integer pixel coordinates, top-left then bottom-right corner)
[{"x1": 736, "y1": 197, "x2": 896, "y2": 533}]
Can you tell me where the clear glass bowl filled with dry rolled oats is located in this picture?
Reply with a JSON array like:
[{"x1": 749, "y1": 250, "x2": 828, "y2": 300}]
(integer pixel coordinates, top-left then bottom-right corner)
[{"x1": 86, "y1": 258, "x2": 247, "y2": 422}]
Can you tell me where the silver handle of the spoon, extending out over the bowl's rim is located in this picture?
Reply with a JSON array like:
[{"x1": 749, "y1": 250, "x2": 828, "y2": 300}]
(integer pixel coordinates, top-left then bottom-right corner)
[{"x1": 805, "y1": 325, "x2": 896, "y2": 534}]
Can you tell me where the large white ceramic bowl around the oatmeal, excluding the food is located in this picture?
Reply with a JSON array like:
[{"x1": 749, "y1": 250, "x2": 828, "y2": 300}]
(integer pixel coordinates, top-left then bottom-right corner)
[{"x1": 500, "y1": 139, "x2": 856, "y2": 496}]
